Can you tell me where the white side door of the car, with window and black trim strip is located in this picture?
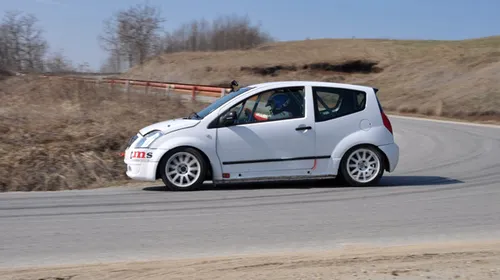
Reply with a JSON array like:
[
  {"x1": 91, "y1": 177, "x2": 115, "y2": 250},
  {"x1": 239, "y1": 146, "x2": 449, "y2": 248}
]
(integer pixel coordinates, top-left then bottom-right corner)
[{"x1": 216, "y1": 86, "x2": 316, "y2": 178}]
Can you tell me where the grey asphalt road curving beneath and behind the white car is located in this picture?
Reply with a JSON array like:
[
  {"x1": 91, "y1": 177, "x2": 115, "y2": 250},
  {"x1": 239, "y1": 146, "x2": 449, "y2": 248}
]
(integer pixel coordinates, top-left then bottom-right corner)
[{"x1": 0, "y1": 117, "x2": 500, "y2": 267}]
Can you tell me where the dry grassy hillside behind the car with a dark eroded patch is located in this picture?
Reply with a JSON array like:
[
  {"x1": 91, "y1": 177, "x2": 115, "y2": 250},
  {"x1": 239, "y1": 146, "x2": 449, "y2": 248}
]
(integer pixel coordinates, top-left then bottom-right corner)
[{"x1": 124, "y1": 36, "x2": 500, "y2": 120}]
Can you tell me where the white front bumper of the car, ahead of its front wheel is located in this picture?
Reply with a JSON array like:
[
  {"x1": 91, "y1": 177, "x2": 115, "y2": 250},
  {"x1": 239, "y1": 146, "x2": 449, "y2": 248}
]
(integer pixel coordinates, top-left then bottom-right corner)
[{"x1": 124, "y1": 149, "x2": 158, "y2": 182}]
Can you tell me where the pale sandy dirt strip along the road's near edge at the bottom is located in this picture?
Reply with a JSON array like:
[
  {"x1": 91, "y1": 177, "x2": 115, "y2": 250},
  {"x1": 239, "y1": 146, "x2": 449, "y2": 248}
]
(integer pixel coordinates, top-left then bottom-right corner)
[{"x1": 0, "y1": 242, "x2": 500, "y2": 280}]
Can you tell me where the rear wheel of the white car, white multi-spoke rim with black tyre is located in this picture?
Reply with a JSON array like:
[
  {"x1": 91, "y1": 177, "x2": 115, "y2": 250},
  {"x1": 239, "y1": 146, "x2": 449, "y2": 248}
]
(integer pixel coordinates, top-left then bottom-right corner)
[{"x1": 340, "y1": 146, "x2": 384, "y2": 187}]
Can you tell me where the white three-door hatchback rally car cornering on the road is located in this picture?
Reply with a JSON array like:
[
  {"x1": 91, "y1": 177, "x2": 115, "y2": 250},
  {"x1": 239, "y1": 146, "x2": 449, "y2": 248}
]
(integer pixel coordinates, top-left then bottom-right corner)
[{"x1": 124, "y1": 81, "x2": 399, "y2": 190}]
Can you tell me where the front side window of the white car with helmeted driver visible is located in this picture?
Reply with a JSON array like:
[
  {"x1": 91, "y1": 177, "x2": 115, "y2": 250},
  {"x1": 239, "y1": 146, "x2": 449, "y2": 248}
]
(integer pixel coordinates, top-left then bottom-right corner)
[{"x1": 219, "y1": 87, "x2": 305, "y2": 125}]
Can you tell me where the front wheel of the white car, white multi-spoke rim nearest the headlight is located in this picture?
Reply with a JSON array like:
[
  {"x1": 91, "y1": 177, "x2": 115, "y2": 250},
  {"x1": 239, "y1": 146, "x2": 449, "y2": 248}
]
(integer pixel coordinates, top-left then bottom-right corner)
[{"x1": 160, "y1": 148, "x2": 207, "y2": 191}]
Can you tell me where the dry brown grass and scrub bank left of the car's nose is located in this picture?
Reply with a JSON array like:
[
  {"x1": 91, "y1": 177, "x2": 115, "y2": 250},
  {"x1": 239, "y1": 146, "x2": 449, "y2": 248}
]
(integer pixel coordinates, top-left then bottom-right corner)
[{"x1": 0, "y1": 77, "x2": 207, "y2": 191}]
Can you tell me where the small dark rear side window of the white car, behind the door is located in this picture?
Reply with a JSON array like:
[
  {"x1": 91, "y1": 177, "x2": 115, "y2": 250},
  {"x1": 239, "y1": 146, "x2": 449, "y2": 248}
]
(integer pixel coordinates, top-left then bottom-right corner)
[{"x1": 312, "y1": 87, "x2": 366, "y2": 122}]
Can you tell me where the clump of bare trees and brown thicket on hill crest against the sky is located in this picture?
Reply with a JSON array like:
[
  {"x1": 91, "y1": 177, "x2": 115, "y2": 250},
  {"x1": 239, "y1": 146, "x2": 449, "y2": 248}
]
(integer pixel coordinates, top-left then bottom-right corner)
[{"x1": 99, "y1": 10, "x2": 274, "y2": 72}]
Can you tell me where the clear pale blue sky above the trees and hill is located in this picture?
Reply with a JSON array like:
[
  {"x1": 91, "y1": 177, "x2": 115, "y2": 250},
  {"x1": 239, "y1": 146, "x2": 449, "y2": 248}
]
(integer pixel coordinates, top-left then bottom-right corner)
[{"x1": 0, "y1": 0, "x2": 500, "y2": 71}]
